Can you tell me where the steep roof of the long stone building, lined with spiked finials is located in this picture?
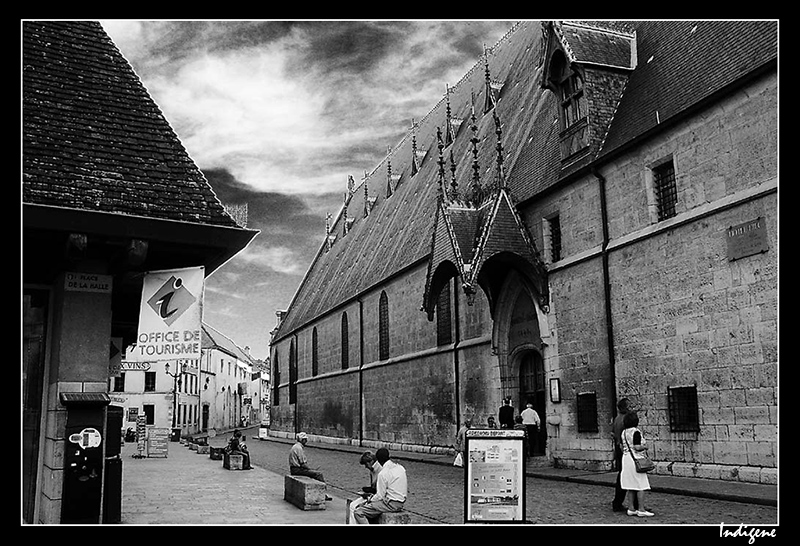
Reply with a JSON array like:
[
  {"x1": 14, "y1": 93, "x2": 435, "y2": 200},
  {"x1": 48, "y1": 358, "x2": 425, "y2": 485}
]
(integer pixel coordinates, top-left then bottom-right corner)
[{"x1": 273, "y1": 21, "x2": 777, "y2": 342}]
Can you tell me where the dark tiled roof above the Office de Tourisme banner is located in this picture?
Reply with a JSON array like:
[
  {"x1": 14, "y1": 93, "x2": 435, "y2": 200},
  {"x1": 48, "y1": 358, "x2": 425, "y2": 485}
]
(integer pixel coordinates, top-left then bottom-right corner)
[{"x1": 22, "y1": 21, "x2": 237, "y2": 227}]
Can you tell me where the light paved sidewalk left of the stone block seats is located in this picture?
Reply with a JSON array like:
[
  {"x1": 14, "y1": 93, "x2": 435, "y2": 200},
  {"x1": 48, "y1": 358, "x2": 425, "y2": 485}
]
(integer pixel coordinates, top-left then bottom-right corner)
[{"x1": 121, "y1": 442, "x2": 347, "y2": 525}]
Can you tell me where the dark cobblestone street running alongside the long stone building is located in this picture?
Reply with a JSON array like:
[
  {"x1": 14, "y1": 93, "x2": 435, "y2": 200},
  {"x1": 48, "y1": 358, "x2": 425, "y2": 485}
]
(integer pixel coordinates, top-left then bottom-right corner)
[{"x1": 248, "y1": 434, "x2": 778, "y2": 526}]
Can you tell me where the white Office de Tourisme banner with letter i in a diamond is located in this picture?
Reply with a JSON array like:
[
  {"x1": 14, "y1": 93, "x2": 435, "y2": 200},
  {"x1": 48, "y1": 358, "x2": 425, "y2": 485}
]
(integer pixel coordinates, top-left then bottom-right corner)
[{"x1": 126, "y1": 266, "x2": 205, "y2": 362}]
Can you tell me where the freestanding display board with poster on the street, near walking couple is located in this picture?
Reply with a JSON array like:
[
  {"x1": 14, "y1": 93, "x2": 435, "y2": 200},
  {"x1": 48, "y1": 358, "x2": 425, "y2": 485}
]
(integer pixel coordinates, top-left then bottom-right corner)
[{"x1": 464, "y1": 429, "x2": 525, "y2": 523}]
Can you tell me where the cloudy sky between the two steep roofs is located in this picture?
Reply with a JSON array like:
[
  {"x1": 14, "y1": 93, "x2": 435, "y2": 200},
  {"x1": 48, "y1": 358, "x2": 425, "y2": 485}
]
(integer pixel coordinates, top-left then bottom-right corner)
[{"x1": 101, "y1": 19, "x2": 513, "y2": 360}]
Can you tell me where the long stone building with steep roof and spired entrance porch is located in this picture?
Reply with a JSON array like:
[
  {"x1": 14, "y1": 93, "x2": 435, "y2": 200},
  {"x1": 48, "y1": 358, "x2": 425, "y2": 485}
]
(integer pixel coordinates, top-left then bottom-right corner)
[{"x1": 270, "y1": 21, "x2": 778, "y2": 482}]
